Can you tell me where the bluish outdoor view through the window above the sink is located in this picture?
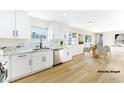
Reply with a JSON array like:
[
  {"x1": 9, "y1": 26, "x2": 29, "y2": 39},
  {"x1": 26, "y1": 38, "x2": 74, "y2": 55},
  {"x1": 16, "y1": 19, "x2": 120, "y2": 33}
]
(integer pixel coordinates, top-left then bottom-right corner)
[{"x1": 31, "y1": 26, "x2": 48, "y2": 43}]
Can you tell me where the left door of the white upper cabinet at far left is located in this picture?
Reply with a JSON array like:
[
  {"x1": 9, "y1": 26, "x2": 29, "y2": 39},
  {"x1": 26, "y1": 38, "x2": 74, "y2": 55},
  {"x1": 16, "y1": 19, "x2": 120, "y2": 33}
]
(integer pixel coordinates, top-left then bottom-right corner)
[{"x1": 0, "y1": 10, "x2": 15, "y2": 38}]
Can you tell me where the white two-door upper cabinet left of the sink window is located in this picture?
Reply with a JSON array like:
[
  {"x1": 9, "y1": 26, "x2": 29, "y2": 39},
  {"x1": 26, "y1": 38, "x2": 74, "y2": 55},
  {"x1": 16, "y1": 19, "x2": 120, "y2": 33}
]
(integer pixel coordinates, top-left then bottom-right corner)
[{"x1": 0, "y1": 10, "x2": 28, "y2": 39}]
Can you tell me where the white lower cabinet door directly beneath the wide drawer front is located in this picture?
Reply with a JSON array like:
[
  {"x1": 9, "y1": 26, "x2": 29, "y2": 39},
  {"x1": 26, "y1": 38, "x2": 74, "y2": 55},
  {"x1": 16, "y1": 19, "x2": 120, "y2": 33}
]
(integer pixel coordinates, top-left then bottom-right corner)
[{"x1": 11, "y1": 59, "x2": 31, "y2": 79}]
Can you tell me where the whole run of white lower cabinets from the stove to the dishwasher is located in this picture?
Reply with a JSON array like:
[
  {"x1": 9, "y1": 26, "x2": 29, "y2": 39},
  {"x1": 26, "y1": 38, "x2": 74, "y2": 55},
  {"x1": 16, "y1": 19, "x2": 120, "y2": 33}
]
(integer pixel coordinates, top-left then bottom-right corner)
[{"x1": 9, "y1": 50, "x2": 53, "y2": 81}]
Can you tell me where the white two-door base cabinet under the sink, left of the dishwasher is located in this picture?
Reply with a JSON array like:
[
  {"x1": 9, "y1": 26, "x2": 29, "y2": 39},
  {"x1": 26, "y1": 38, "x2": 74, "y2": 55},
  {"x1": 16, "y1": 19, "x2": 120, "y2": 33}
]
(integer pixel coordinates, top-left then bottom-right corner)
[{"x1": 32, "y1": 50, "x2": 53, "y2": 71}]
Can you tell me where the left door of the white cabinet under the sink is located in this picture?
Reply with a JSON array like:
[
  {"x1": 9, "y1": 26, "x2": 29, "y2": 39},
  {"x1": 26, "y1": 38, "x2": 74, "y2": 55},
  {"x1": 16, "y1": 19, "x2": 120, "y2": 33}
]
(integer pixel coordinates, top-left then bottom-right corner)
[{"x1": 32, "y1": 55, "x2": 45, "y2": 71}]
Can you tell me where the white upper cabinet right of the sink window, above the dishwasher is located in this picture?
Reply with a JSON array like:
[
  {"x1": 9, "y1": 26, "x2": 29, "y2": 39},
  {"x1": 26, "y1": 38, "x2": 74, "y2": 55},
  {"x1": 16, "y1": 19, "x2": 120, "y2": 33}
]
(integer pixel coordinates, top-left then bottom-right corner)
[{"x1": 49, "y1": 21, "x2": 68, "y2": 39}]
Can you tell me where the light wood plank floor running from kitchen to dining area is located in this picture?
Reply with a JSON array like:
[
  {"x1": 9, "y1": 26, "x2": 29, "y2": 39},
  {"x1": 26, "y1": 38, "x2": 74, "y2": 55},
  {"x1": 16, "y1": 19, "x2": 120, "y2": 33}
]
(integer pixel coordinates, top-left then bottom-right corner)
[{"x1": 14, "y1": 54, "x2": 124, "y2": 83}]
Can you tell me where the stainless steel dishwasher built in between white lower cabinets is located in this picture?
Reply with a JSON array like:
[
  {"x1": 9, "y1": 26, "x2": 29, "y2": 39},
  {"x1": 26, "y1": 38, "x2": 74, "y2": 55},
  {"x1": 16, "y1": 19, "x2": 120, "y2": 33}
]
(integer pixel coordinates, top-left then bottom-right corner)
[{"x1": 53, "y1": 48, "x2": 63, "y2": 66}]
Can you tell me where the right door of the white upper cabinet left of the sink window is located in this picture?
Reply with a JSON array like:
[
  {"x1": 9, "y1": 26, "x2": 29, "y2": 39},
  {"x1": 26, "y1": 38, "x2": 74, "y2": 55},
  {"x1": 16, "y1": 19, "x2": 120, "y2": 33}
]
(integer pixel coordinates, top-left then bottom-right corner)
[{"x1": 16, "y1": 11, "x2": 28, "y2": 39}]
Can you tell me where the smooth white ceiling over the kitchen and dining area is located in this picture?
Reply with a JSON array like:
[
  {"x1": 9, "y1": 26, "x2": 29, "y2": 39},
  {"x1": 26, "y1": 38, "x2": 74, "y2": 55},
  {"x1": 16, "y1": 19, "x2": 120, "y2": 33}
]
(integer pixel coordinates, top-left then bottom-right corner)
[{"x1": 28, "y1": 10, "x2": 124, "y2": 32}]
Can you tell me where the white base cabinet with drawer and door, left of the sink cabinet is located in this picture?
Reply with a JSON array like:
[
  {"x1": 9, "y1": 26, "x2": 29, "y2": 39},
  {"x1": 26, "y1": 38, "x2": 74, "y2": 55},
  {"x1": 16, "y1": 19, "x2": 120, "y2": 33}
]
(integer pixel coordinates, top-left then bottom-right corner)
[{"x1": 10, "y1": 53, "x2": 31, "y2": 80}]
